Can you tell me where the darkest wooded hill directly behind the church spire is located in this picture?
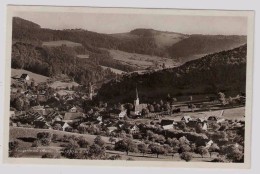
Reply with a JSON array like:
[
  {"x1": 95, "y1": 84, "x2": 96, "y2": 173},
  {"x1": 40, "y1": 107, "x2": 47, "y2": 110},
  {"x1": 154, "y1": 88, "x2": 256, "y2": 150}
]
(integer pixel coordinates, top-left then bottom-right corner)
[{"x1": 97, "y1": 45, "x2": 247, "y2": 103}]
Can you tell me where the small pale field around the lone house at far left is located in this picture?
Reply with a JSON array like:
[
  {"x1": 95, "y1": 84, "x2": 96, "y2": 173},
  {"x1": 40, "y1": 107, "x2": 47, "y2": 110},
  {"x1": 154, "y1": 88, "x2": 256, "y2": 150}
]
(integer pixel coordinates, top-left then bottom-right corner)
[{"x1": 11, "y1": 69, "x2": 49, "y2": 83}]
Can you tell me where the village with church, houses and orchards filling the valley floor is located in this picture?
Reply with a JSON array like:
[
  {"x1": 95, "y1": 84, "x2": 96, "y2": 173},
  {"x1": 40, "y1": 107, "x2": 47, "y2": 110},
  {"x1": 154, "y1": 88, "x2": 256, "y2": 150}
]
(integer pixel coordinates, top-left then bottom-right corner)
[{"x1": 9, "y1": 74, "x2": 245, "y2": 162}]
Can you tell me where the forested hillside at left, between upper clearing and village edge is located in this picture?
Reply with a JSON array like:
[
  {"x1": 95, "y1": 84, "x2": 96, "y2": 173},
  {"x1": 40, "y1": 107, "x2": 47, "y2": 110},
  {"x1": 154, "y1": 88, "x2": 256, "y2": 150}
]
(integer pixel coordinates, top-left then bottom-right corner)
[{"x1": 12, "y1": 42, "x2": 114, "y2": 84}]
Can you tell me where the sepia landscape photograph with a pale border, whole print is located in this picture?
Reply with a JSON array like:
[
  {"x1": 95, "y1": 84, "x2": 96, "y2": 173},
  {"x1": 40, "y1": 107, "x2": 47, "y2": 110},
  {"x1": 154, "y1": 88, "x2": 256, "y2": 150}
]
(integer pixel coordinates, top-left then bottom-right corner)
[{"x1": 4, "y1": 6, "x2": 254, "y2": 167}]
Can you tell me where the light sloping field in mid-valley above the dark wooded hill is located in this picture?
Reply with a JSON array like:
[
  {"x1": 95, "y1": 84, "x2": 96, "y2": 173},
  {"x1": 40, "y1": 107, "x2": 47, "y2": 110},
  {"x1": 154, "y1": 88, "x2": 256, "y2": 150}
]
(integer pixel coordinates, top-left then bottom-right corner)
[{"x1": 108, "y1": 50, "x2": 177, "y2": 70}]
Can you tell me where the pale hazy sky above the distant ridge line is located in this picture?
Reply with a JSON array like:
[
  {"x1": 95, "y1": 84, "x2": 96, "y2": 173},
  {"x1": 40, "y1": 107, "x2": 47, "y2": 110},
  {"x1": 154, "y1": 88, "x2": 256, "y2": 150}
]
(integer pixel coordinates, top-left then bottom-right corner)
[{"x1": 15, "y1": 12, "x2": 247, "y2": 35}]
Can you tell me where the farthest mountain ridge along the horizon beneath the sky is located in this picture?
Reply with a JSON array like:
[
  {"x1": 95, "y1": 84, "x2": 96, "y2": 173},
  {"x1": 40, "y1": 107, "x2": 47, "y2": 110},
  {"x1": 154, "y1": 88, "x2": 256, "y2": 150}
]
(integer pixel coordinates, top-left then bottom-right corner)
[{"x1": 13, "y1": 17, "x2": 246, "y2": 62}]
